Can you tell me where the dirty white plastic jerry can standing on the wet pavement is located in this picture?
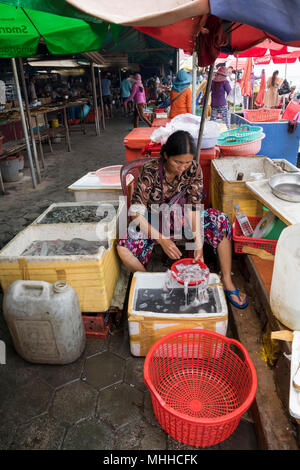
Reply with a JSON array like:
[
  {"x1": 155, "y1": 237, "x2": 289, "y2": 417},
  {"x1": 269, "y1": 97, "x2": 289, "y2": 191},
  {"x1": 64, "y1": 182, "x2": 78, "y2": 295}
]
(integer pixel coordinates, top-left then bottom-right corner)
[{"x1": 3, "y1": 281, "x2": 86, "y2": 364}]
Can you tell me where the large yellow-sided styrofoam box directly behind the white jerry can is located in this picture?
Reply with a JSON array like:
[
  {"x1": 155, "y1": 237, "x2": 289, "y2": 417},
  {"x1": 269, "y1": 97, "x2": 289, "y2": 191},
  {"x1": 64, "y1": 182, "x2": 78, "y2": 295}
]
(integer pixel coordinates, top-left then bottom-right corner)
[{"x1": 0, "y1": 224, "x2": 120, "y2": 312}]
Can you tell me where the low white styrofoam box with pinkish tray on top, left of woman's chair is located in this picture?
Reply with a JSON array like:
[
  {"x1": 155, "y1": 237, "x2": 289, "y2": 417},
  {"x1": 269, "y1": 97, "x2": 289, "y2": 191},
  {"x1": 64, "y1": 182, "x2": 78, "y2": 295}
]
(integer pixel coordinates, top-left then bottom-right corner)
[{"x1": 68, "y1": 171, "x2": 134, "y2": 202}]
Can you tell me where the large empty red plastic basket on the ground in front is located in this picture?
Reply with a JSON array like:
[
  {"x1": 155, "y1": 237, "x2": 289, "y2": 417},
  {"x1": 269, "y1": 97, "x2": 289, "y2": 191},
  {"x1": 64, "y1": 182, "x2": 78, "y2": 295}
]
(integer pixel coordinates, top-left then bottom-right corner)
[{"x1": 144, "y1": 329, "x2": 257, "y2": 447}]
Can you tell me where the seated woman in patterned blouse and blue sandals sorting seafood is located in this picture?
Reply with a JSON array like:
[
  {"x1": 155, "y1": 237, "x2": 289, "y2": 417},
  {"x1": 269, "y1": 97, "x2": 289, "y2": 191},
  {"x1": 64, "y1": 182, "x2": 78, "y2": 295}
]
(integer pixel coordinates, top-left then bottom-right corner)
[{"x1": 117, "y1": 131, "x2": 248, "y2": 308}]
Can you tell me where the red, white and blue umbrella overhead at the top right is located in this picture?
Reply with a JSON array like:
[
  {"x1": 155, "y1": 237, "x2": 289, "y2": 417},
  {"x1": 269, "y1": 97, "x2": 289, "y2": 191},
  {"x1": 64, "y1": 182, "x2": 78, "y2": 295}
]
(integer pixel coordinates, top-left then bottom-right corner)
[{"x1": 66, "y1": 0, "x2": 300, "y2": 66}]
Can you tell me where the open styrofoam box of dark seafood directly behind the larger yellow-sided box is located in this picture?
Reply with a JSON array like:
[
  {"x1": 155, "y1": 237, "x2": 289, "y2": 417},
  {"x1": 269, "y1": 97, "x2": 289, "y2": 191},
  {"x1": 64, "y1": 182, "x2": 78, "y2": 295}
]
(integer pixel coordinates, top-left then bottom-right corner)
[{"x1": 32, "y1": 197, "x2": 127, "y2": 236}]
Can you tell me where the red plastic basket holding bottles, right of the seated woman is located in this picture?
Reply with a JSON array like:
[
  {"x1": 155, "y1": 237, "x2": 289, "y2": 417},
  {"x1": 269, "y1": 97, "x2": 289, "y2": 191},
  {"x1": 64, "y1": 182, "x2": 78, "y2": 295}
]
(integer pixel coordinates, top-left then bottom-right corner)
[{"x1": 232, "y1": 217, "x2": 278, "y2": 255}]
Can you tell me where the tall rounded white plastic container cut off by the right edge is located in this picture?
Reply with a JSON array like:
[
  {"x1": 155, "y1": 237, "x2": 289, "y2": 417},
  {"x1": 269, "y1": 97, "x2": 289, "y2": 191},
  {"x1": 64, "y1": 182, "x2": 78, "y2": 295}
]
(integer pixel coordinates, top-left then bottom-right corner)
[{"x1": 270, "y1": 224, "x2": 300, "y2": 330}]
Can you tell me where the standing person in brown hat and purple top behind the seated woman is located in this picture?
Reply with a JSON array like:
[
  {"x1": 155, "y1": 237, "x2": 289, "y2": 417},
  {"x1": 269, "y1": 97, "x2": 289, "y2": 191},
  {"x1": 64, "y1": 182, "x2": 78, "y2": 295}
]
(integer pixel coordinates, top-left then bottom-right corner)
[{"x1": 210, "y1": 66, "x2": 231, "y2": 129}]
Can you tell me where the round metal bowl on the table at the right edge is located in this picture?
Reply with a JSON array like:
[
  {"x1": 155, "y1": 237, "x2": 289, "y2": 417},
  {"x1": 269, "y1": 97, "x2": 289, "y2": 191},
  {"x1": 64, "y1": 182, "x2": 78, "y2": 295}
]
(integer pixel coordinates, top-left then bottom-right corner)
[{"x1": 269, "y1": 172, "x2": 300, "y2": 202}]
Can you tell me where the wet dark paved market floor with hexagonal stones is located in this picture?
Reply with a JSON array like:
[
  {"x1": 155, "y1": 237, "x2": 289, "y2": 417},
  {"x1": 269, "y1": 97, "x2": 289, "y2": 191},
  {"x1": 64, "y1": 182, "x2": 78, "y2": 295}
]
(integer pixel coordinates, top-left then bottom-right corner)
[{"x1": 0, "y1": 117, "x2": 258, "y2": 450}]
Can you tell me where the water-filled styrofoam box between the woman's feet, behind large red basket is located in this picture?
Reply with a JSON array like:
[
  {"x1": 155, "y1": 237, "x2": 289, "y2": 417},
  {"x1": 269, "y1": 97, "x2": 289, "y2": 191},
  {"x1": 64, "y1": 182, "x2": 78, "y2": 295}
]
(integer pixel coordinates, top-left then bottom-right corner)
[{"x1": 128, "y1": 272, "x2": 228, "y2": 356}]
